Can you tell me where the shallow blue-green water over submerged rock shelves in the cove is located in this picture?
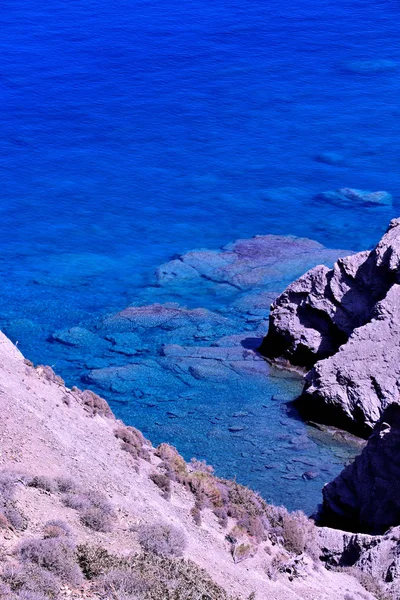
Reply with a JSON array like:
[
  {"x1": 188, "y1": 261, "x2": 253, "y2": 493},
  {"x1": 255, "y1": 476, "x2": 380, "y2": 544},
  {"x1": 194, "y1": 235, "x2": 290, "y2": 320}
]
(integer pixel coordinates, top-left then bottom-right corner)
[{"x1": 0, "y1": 235, "x2": 359, "y2": 513}]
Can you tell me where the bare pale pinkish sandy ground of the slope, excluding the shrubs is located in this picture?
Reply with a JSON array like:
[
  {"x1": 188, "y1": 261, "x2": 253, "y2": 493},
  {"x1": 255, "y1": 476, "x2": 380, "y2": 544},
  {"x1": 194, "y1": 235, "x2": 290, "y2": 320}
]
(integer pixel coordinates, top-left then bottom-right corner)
[{"x1": 0, "y1": 333, "x2": 370, "y2": 600}]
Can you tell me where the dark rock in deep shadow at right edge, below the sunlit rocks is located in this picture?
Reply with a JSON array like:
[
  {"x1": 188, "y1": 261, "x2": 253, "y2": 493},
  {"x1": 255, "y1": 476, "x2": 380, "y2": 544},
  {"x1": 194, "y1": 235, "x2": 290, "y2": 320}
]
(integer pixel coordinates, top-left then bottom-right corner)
[{"x1": 321, "y1": 404, "x2": 400, "y2": 534}]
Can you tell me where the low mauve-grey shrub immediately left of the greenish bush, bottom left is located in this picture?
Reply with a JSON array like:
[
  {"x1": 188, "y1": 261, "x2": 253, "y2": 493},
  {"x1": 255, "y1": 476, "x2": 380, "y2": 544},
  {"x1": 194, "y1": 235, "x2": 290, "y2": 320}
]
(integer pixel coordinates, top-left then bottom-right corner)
[{"x1": 16, "y1": 537, "x2": 82, "y2": 585}]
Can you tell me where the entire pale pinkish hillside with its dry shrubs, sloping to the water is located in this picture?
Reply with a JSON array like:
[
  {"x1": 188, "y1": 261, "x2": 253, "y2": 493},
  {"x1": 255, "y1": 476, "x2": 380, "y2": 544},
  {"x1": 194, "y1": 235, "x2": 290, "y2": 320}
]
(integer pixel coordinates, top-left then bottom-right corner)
[{"x1": 0, "y1": 333, "x2": 372, "y2": 600}]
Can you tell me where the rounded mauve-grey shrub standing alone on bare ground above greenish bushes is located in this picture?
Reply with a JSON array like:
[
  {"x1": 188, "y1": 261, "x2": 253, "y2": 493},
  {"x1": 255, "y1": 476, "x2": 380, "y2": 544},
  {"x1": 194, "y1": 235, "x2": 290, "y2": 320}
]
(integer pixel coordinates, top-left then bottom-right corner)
[{"x1": 139, "y1": 523, "x2": 187, "y2": 556}]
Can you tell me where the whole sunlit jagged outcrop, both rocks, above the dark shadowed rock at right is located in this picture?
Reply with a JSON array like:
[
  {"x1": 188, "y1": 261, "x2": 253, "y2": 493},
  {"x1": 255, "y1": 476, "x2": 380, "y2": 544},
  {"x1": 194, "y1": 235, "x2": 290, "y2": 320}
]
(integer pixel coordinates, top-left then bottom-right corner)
[{"x1": 261, "y1": 219, "x2": 400, "y2": 436}]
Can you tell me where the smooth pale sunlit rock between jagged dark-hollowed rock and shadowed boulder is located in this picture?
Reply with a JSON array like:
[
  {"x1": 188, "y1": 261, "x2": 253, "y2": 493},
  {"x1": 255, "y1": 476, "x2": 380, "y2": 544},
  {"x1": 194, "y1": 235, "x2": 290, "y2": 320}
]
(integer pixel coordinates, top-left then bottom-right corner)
[{"x1": 301, "y1": 284, "x2": 400, "y2": 436}]
